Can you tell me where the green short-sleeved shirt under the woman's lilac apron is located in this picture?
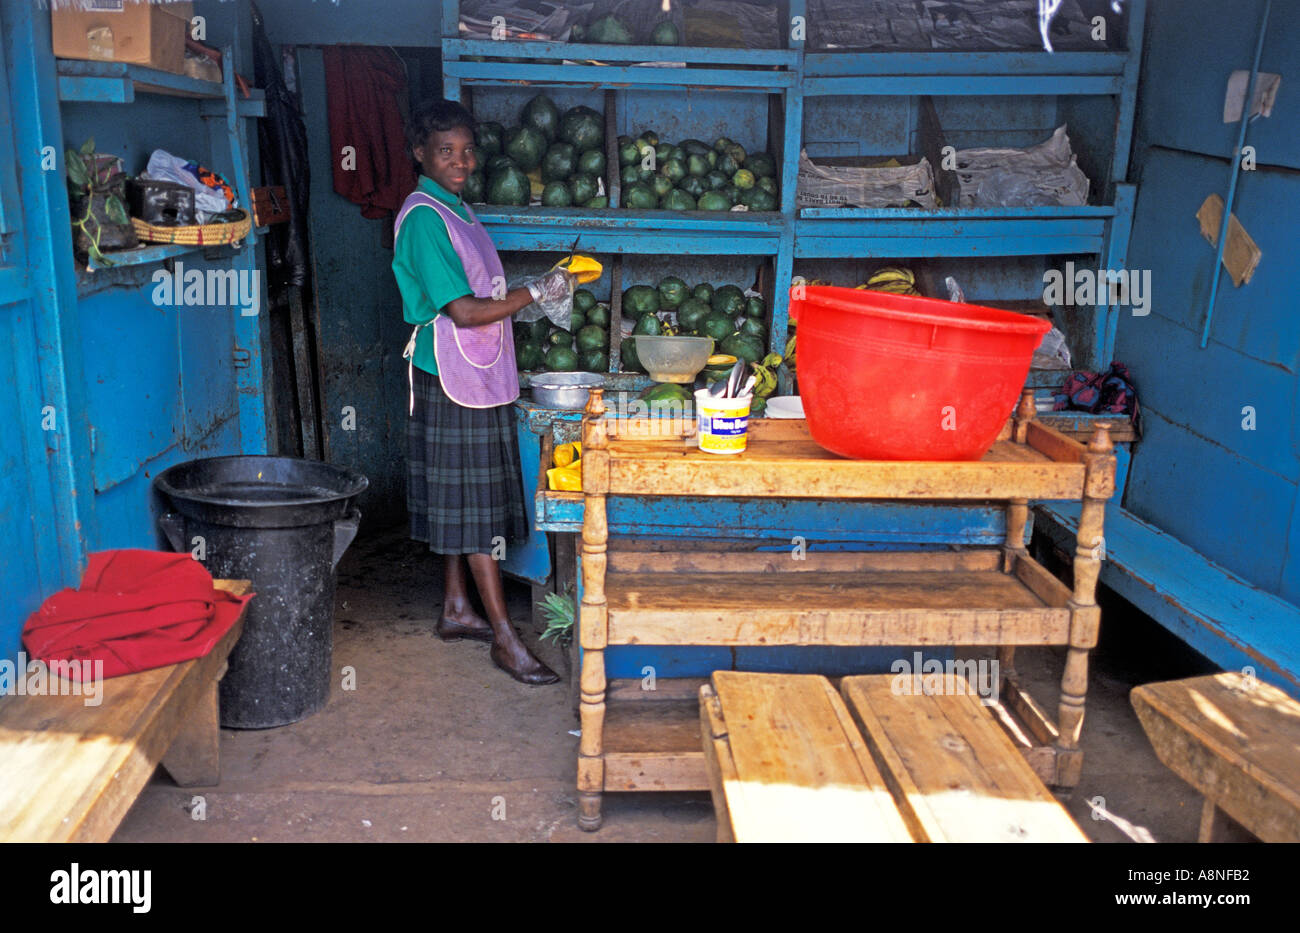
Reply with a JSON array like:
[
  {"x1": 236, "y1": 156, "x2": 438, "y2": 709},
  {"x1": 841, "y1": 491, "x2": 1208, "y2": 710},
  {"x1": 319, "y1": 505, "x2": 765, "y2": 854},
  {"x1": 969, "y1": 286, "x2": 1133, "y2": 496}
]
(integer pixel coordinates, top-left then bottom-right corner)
[{"x1": 393, "y1": 175, "x2": 473, "y2": 376}]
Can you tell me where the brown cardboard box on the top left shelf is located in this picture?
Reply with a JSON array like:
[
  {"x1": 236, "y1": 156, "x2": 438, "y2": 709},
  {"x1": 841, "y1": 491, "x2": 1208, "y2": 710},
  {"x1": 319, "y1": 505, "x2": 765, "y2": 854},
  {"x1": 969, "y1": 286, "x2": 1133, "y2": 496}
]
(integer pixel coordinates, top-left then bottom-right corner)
[{"x1": 49, "y1": 0, "x2": 192, "y2": 74}]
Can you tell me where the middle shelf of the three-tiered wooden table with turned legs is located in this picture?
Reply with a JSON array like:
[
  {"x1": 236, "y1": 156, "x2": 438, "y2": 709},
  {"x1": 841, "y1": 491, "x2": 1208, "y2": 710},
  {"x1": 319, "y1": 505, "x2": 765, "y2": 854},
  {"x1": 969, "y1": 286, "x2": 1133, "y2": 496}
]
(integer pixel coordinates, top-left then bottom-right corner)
[{"x1": 606, "y1": 548, "x2": 1070, "y2": 646}]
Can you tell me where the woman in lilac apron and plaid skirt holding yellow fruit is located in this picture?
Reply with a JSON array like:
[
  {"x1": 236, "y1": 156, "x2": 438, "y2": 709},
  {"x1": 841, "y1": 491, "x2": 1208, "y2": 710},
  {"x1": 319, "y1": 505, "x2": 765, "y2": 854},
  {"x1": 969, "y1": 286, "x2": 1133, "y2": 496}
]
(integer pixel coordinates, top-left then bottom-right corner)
[{"x1": 393, "y1": 100, "x2": 573, "y2": 685}]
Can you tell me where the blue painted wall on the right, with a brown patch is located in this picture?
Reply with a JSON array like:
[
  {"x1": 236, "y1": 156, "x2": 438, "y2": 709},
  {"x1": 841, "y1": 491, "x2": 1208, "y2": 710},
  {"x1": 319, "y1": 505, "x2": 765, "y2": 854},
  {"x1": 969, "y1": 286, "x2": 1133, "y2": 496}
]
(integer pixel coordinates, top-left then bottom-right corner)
[{"x1": 1115, "y1": 0, "x2": 1300, "y2": 602}]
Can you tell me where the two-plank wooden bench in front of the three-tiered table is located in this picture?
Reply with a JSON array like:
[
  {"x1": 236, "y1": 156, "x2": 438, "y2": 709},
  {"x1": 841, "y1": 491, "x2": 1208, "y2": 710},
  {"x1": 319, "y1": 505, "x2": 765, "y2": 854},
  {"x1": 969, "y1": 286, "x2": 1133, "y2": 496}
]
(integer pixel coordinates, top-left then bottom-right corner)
[{"x1": 699, "y1": 671, "x2": 1087, "y2": 842}]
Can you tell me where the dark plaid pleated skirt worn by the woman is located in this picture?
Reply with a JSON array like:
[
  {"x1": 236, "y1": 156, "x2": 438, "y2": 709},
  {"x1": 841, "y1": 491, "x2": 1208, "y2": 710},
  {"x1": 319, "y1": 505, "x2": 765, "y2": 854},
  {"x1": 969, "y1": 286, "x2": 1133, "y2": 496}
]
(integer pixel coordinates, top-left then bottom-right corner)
[{"x1": 407, "y1": 369, "x2": 528, "y2": 554}]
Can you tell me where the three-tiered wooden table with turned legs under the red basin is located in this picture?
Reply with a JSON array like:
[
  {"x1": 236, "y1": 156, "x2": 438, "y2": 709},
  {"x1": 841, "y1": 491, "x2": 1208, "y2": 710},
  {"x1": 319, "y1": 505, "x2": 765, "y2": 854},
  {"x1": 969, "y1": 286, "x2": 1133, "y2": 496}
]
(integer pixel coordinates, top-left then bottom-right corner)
[{"x1": 577, "y1": 390, "x2": 1115, "y2": 830}]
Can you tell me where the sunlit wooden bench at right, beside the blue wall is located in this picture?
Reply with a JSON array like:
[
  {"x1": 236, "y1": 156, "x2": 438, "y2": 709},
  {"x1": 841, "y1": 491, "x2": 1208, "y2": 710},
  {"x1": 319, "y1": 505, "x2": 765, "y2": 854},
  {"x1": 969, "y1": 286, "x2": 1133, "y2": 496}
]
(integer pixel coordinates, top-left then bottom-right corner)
[{"x1": 1130, "y1": 672, "x2": 1300, "y2": 842}]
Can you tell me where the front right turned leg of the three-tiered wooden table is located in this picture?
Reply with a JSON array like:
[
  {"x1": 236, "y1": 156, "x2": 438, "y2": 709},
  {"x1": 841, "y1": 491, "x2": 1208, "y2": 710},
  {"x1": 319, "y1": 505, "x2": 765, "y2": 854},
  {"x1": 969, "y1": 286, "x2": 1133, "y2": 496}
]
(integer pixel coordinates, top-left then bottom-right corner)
[{"x1": 1056, "y1": 424, "x2": 1115, "y2": 787}]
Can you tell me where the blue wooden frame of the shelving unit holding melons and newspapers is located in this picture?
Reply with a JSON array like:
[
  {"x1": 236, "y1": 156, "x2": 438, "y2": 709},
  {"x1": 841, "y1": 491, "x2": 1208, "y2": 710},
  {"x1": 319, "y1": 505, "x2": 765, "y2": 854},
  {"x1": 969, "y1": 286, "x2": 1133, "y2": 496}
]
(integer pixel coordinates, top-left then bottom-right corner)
[{"x1": 442, "y1": 0, "x2": 1145, "y2": 365}]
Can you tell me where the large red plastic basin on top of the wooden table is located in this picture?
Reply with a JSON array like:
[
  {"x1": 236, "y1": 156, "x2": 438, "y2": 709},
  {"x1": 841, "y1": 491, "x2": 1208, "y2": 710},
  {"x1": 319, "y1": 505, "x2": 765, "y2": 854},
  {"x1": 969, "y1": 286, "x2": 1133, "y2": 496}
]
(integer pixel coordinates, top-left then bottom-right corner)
[{"x1": 790, "y1": 286, "x2": 1052, "y2": 460}]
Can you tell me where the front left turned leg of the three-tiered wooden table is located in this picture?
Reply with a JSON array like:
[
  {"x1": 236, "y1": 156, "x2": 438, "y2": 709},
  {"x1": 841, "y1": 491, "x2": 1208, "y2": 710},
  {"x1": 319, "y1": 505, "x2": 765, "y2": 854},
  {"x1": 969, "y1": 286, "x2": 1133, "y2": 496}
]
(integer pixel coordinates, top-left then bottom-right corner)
[{"x1": 577, "y1": 389, "x2": 610, "y2": 832}]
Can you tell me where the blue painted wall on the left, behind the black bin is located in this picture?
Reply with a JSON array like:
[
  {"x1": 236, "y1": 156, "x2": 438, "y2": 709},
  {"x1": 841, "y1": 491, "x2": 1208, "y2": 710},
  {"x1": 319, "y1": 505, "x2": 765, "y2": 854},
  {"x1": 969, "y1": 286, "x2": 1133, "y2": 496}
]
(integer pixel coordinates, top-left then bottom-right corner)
[{"x1": 0, "y1": 0, "x2": 265, "y2": 656}]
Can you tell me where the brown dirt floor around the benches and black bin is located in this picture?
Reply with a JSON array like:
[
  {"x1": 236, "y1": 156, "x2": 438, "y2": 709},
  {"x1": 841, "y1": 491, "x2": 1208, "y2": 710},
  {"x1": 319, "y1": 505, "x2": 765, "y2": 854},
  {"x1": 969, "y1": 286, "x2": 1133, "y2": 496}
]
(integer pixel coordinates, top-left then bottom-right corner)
[{"x1": 114, "y1": 529, "x2": 1213, "y2": 842}]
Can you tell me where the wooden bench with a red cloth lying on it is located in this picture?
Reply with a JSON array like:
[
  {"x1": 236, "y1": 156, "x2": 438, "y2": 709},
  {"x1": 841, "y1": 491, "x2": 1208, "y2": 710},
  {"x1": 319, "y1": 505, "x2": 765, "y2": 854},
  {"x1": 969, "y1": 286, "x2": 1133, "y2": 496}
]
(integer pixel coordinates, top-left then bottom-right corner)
[{"x1": 0, "y1": 580, "x2": 250, "y2": 842}]
